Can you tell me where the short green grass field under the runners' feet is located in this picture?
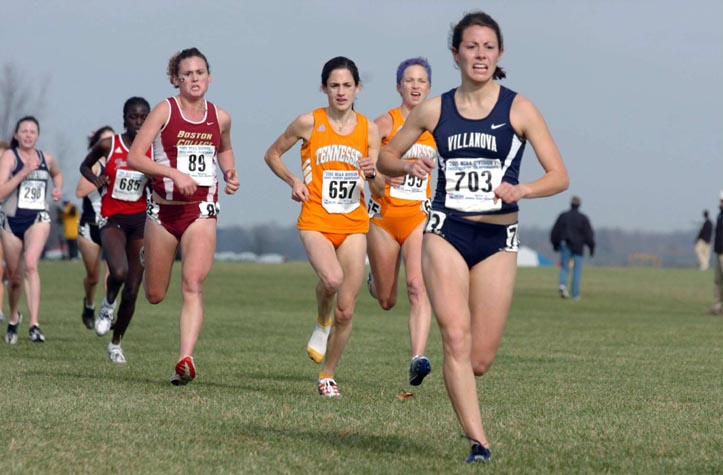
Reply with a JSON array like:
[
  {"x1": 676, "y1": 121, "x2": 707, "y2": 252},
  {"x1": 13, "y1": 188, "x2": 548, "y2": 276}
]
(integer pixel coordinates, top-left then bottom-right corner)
[{"x1": 0, "y1": 262, "x2": 723, "y2": 474}]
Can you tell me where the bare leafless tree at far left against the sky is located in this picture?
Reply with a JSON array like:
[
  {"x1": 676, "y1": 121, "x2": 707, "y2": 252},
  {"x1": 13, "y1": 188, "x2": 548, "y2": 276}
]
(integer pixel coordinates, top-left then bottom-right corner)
[{"x1": 0, "y1": 63, "x2": 50, "y2": 141}]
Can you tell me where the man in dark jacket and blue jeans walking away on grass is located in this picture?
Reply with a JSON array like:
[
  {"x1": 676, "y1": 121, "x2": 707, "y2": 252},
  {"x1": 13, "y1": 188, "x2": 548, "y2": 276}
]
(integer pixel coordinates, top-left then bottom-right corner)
[{"x1": 550, "y1": 196, "x2": 595, "y2": 300}]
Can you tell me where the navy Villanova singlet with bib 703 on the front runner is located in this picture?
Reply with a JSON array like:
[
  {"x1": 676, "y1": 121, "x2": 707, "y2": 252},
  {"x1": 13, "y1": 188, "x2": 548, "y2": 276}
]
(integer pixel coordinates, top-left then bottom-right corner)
[{"x1": 432, "y1": 86, "x2": 525, "y2": 216}]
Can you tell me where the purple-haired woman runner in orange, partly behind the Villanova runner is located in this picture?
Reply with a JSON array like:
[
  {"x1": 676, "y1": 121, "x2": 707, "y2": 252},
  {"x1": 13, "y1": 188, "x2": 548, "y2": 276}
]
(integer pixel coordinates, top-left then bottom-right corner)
[{"x1": 367, "y1": 58, "x2": 437, "y2": 386}]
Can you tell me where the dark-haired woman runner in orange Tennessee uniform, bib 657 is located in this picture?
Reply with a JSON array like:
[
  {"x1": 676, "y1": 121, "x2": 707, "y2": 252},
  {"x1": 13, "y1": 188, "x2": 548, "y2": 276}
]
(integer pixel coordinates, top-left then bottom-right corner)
[{"x1": 264, "y1": 56, "x2": 380, "y2": 397}]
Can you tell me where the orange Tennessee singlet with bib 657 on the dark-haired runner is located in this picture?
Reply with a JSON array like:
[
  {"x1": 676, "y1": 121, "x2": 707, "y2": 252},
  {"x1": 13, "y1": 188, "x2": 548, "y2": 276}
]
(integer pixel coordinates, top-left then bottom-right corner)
[{"x1": 296, "y1": 107, "x2": 369, "y2": 234}]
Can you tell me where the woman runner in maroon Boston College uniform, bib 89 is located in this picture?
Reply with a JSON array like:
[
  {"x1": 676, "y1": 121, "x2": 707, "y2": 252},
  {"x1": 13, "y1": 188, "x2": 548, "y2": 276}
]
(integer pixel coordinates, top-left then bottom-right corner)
[{"x1": 128, "y1": 48, "x2": 239, "y2": 385}]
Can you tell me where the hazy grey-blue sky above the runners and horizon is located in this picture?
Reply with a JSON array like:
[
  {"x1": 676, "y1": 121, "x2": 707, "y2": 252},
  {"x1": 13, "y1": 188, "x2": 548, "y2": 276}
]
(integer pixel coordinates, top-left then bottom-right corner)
[{"x1": 0, "y1": 0, "x2": 723, "y2": 234}]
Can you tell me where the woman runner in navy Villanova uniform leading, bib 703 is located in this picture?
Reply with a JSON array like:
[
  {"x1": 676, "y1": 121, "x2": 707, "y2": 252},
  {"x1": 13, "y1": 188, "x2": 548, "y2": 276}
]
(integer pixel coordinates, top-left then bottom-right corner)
[{"x1": 378, "y1": 12, "x2": 569, "y2": 462}]
